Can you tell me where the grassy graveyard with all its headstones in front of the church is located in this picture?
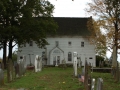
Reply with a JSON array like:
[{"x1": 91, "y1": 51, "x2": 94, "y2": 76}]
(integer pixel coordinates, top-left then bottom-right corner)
[{"x1": 0, "y1": 52, "x2": 120, "y2": 90}]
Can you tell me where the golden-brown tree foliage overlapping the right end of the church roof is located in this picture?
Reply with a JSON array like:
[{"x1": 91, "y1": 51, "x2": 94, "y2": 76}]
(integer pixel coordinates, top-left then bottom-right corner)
[{"x1": 87, "y1": 19, "x2": 107, "y2": 57}]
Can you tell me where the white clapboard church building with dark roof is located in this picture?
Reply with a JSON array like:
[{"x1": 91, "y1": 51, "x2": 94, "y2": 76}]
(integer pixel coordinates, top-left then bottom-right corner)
[{"x1": 18, "y1": 17, "x2": 96, "y2": 67}]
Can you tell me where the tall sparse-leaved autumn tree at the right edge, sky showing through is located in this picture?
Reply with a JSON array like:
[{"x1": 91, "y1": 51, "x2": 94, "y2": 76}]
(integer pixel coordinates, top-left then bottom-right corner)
[{"x1": 86, "y1": 0, "x2": 120, "y2": 61}]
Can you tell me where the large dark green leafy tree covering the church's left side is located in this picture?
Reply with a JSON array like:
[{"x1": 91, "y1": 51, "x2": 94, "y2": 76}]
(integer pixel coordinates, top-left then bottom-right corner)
[{"x1": 0, "y1": 0, "x2": 57, "y2": 67}]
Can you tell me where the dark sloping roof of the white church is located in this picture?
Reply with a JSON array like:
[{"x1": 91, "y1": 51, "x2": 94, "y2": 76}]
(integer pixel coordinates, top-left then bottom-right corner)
[{"x1": 53, "y1": 17, "x2": 92, "y2": 36}]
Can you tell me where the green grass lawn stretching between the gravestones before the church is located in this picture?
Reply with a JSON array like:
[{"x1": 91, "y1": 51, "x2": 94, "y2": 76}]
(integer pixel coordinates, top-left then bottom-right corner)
[{"x1": 0, "y1": 67, "x2": 120, "y2": 90}]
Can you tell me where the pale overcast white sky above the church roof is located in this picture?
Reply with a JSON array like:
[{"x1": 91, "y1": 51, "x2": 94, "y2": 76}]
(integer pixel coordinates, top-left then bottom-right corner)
[{"x1": 0, "y1": 0, "x2": 111, "y2": 58}]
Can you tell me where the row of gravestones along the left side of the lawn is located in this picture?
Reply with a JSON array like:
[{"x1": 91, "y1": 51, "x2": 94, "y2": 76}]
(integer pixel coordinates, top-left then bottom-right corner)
[{"x1": 0, "y1": 55, "x2": 42, "y2": 86}]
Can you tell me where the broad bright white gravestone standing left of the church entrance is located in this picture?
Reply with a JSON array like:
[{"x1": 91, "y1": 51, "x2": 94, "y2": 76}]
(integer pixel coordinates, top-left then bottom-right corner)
[{"x1": 35, "y1": 55, "x2": 42, "y2": 72}]
